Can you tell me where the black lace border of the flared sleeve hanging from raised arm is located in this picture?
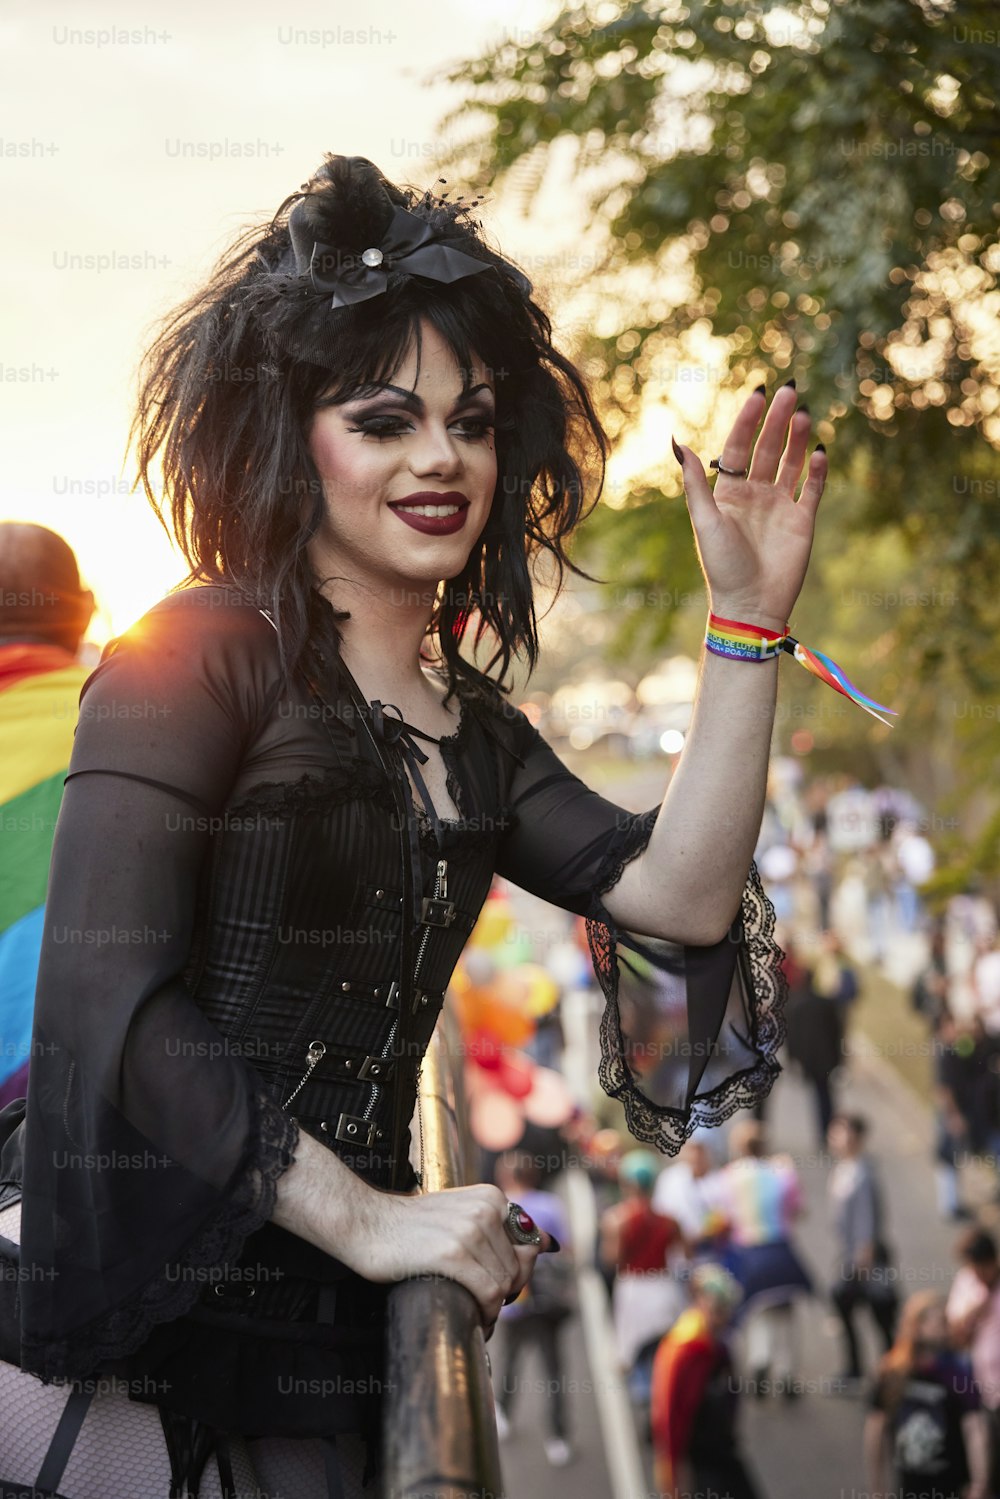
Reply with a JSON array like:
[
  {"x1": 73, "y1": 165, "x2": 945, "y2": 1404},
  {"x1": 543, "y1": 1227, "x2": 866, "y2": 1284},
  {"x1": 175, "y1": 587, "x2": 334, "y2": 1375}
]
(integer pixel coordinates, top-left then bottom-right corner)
[{"x1": 586, "y1": 827, "x2": 789, "y2": 1156}]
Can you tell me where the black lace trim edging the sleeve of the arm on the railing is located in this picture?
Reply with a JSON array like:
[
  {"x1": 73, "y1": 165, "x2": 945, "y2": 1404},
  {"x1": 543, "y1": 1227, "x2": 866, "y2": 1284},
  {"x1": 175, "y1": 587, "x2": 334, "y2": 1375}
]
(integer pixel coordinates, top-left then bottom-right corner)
[{"x1": 21, "y1": 1093, "x2": 298, "y2": 1384}]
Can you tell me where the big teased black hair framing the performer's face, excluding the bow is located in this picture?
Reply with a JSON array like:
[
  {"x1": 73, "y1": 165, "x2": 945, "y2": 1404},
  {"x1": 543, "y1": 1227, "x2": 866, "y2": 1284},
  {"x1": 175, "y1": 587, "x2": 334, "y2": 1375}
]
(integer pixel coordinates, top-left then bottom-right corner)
[{"x1": 130, "y1": 154, "x2": 607, "y2": 702}]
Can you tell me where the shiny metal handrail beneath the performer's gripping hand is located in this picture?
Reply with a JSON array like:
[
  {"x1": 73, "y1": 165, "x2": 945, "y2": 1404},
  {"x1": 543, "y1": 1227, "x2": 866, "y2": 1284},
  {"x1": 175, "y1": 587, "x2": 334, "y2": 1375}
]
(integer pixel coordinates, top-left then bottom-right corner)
[{"x1": 382, "y1": 1004, "x2": 504, "y2": 1499}]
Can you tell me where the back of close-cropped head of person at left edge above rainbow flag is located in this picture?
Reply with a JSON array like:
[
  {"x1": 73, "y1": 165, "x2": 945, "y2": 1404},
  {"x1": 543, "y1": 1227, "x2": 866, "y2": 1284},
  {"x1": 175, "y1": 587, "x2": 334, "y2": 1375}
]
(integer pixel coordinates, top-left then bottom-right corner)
[{"x1": 0, "y1": 520, "x2": 94, "y2": 655}]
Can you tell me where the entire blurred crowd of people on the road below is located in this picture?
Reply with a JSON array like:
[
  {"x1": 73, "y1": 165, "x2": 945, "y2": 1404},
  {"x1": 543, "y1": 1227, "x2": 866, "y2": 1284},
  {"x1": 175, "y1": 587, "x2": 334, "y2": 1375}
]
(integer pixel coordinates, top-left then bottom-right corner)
[{"x1": 479, "y1": 769, "x2": 1000, "y2": 1499}]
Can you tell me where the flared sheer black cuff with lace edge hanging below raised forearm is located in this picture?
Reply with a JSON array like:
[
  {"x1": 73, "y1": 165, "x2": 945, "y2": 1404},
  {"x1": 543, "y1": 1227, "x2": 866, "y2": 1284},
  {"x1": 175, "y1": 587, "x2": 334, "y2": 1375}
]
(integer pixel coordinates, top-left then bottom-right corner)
[{"x1": 586, "y1": 808, "x2": 787, "y2": 1156}]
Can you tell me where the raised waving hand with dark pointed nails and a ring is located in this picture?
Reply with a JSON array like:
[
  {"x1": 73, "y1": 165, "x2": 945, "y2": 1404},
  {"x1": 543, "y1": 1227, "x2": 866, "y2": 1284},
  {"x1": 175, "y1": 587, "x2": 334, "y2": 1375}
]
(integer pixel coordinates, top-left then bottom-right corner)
[{"x1": 673, "y1": 382, "x2": 828, "y2": 630}]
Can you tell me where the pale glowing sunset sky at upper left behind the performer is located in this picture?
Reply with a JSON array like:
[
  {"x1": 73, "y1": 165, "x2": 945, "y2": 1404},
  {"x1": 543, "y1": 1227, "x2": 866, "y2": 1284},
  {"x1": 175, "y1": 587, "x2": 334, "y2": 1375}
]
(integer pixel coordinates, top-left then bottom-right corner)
[{"x1": 0, "y1": 0, "x2": 602, "y2": 642}]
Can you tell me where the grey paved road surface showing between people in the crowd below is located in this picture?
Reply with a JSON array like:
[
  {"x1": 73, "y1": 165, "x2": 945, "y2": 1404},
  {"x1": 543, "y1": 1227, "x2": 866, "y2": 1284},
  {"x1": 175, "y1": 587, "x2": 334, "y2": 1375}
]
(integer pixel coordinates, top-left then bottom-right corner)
[{"x1": 495, "y1": 1007, "x2": 996, "y2": 1499}]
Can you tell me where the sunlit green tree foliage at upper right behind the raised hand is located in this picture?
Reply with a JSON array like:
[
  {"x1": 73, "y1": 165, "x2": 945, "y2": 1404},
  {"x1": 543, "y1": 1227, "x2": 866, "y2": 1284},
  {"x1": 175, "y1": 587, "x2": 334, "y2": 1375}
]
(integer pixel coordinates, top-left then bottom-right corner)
[{"x1": 442, "y1": 0, "x2": 1000, "y2": 875}]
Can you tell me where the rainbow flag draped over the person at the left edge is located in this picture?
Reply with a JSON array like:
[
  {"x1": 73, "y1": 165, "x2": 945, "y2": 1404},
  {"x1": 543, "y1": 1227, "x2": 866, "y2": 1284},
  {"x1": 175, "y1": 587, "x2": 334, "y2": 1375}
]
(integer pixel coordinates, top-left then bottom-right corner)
[{"x1": 0, "y1": 642, "x2": 90, "y2": 1108}]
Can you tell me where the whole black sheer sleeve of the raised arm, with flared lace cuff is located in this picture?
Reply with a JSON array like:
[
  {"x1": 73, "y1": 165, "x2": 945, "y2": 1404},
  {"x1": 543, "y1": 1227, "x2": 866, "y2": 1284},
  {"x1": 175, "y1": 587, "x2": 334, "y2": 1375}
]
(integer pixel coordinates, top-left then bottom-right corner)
[{"x1": 496, "y1": 715, "x2": 787, "y2": 1154}]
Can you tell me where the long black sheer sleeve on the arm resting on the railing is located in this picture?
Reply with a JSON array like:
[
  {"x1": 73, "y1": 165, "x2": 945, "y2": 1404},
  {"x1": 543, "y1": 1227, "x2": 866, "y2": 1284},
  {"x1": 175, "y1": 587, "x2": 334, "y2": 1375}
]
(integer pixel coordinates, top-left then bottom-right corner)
[{"x1": 21, "y1": 591, "x2": 297, "y2": 1379}]
